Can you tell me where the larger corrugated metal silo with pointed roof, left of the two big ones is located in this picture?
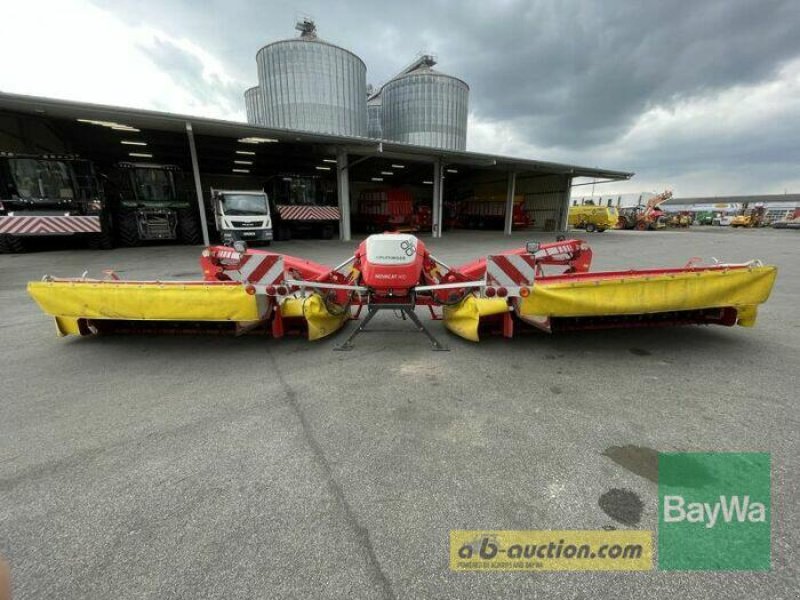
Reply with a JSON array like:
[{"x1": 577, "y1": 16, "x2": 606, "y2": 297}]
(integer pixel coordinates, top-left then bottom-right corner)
[{"x1": 256, "y1": 20, "x2": 367, "y2": 137}]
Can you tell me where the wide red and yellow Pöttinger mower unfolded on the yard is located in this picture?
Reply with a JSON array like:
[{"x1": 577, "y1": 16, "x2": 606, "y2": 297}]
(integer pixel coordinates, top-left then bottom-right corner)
[{"x1": 28, "y1": 233, "x2": 777, "y2": 350}]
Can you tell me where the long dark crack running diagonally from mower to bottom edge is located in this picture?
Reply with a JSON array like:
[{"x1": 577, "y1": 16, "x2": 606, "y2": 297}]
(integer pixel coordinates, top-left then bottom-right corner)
[{"x1": 267, "y1": 348, "x2": 396, "y2": 600}]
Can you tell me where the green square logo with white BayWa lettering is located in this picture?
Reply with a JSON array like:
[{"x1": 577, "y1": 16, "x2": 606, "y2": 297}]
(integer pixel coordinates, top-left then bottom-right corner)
[{"x1": 658, "y1": 452, "x2": 772, "y2": 571}]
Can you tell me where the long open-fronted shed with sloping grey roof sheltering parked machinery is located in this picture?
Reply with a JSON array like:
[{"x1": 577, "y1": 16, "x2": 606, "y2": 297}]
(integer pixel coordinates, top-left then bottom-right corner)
[{"x1": 0, "y1": 88, "x2": 633, "y2": 246}]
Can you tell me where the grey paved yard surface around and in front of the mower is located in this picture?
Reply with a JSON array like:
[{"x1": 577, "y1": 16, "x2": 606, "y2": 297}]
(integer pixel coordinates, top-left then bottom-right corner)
[{"x1": 0, "y1": 228, "x2": 800, "y2": 600}]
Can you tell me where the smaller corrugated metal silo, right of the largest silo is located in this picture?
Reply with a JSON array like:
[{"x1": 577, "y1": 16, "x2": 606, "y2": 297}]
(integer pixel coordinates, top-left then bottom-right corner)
[{"x1": 381, "y1": 57, "x2": 469, "y2": 150}]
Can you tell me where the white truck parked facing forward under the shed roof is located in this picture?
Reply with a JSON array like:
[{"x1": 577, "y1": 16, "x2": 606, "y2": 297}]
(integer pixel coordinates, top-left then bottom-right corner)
[{"x1": 211, "y1": 188, "x2": 272, "y2": 245}]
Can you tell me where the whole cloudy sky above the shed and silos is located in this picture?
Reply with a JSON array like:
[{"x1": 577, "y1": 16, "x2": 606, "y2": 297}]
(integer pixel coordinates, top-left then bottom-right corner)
[{"x1": 0, "y1": 0, "x2": 800, "y2": 196}]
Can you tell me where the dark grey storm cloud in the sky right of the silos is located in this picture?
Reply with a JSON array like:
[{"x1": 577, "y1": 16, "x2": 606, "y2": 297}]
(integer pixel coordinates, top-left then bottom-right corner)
[{"x1": 444, "y1": 0, "x2": 800, "y2": 146}]
